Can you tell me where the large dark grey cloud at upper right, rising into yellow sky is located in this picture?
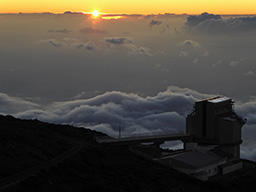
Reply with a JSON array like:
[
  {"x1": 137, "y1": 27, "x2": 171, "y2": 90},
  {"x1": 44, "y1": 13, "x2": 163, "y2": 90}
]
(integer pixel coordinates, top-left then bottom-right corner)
[{"x1": 185, "y1": 13, "x2": 256, "y2": 33}]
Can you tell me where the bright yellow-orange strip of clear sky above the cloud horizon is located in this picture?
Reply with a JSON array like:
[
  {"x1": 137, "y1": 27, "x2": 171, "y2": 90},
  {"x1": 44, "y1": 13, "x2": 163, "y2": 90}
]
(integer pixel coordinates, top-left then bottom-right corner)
[{"x1": 0, "y1": 0, "x2": 256, "y2": 14}]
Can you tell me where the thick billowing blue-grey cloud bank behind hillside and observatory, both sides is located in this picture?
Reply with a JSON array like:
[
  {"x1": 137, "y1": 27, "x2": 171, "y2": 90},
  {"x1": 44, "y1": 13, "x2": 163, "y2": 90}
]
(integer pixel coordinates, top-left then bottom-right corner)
[{"x1": 0, "y1": 86, "x2": 256, "y2": 160}]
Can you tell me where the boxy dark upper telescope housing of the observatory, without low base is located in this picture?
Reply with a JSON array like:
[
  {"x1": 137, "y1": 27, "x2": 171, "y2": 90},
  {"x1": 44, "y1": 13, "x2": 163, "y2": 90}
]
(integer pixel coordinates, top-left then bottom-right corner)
[{"x1": 186, "y1": 97, "x2": 245, "y2": 159}]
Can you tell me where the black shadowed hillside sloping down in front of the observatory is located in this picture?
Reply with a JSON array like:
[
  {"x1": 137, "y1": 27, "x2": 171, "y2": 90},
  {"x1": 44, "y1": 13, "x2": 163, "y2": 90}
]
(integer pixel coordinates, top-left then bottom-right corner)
[{"x1": 0, "y1": 116, "x2": 256, "y2": 192}]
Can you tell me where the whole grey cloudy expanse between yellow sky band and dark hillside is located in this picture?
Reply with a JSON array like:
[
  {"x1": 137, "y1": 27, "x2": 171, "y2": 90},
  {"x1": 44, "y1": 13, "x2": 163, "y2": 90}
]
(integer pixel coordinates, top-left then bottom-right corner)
[{"x1": 0, "y1": 9, "x2": 256, "y2": 160}]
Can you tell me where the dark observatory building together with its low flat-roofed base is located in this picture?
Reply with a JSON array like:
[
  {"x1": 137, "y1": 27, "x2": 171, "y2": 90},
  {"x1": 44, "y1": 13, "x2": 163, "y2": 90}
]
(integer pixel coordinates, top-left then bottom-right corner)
[{"x1": 164, "y1": 97, "x2": 245, "y2": 180}]
